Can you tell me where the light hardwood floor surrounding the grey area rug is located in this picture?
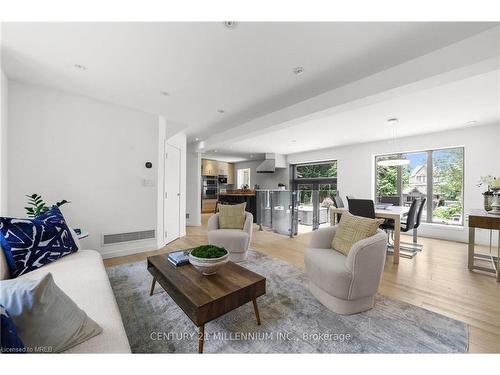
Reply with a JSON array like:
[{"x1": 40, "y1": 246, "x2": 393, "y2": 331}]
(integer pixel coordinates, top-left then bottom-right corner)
[{"x1": 104, "y1": 214, "x2": 500, "y2": 353}]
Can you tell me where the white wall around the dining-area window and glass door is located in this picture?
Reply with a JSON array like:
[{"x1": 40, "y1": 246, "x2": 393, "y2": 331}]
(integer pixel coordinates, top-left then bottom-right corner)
[{"x1": 288, "y1": 124, "x2": 500, "y2": 243}]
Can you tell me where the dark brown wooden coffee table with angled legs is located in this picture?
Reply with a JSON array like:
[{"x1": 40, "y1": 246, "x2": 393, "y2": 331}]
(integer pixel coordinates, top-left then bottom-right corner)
[{"x1": 147, "y1": 254, "x2": 266, "y2": 353}]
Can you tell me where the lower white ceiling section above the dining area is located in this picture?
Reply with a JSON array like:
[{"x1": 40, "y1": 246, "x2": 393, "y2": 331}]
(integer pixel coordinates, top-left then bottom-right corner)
[{"x1": 218, "y1": 70, "x2": 500, "y2": 154}]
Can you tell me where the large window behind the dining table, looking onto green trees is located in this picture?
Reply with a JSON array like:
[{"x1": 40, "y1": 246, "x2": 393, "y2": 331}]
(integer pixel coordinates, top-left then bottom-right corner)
[{"x1": 375, "y1": 147, "x2": 464, "y2": 225}]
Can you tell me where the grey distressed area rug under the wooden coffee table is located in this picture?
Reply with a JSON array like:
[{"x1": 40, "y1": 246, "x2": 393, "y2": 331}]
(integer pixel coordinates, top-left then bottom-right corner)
[{"x1": 107, "y1": 251, "x2": 468, "y2": 353}]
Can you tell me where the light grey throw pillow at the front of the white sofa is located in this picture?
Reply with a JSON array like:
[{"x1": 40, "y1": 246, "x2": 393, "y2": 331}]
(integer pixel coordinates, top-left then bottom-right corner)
[{"x1": 0, "y1": 273, "x2": 102, "y2": 353}]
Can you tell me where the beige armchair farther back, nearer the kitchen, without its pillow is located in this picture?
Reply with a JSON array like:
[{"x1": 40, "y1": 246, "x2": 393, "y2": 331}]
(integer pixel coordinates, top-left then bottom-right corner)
[{"x1": 207, "y1": 212, "x2": 253, "y2": 262}]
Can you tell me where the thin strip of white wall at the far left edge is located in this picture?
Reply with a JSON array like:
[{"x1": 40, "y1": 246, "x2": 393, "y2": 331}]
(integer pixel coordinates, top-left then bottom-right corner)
[{"x1": 0, "y1": 69, "x2": 9, "y2": 216}]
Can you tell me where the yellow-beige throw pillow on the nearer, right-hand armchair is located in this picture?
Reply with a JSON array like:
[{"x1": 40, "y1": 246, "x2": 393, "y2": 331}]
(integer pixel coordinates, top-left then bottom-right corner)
[{"x1": 332, "y1": 212, "x2": 385, "y2": 256}]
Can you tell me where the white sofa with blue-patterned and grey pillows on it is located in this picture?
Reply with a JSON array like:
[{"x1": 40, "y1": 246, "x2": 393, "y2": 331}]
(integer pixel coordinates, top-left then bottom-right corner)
[{"x1": 0, "y1": 245, "x2": 130, "y2": 353}]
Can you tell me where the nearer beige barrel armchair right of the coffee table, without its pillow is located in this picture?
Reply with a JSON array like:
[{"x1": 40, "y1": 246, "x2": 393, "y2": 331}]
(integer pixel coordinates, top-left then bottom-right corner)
[{"x1": 305, "y1": 226, "x2": 387, "y2": 314}]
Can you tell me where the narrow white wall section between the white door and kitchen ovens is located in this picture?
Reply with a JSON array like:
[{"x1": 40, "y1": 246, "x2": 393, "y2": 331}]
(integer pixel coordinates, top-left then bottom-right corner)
[{"x1": 186, "y1": 143, "x2": 201, "y2": 226}]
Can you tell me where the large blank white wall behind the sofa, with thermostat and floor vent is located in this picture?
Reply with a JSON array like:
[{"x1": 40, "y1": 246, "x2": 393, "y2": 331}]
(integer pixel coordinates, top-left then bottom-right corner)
[{"x1": 7, "y1": 81, "x2": 158, "y2": 256}]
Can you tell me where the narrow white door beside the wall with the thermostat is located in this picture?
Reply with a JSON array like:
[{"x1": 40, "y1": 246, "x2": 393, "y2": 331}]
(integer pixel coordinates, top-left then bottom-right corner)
[{"x1": 163, "y1": 143, "x2": 181, "y2": 244}]
